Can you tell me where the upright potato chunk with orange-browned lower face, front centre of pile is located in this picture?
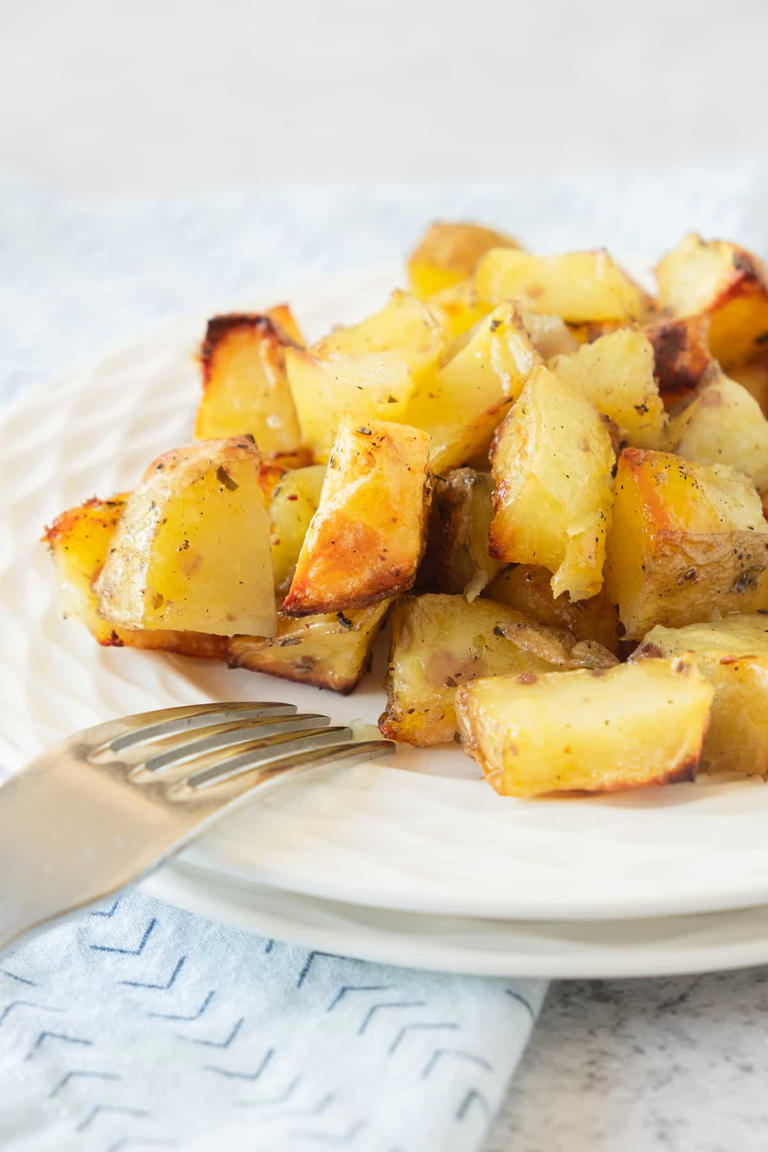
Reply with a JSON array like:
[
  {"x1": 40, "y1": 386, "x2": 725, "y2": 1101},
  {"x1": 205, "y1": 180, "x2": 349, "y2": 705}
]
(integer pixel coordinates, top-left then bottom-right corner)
[{"x1": 282, "y1": 418, "x2": 429, "y2": 616}]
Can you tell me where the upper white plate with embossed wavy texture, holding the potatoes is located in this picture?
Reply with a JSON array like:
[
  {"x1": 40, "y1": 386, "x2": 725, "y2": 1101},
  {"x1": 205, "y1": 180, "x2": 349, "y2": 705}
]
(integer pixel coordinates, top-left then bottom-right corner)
[{"x1": 0, "y1": 263, "x2": 768, "y2": 919}]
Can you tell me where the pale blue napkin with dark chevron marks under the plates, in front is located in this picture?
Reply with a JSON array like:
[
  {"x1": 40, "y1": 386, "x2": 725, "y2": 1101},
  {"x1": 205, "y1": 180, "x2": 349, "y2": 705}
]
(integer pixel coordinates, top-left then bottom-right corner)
[{"x1": 0, "y1": 890, "x2": 545, "y2": 1152}]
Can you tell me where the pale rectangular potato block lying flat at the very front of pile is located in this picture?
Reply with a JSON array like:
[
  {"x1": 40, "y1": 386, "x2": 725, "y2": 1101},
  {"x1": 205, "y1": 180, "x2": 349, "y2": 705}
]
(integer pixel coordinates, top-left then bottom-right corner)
[{"x1": 456, "y1": 657, "x2": 714, "y2": 796}]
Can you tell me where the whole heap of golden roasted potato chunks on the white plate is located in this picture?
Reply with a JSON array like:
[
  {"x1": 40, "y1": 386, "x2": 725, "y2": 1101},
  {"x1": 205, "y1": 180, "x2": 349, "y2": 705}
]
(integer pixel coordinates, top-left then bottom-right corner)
[{"x1": 45, "y1": 223, "x2": 768, "y2": 796}]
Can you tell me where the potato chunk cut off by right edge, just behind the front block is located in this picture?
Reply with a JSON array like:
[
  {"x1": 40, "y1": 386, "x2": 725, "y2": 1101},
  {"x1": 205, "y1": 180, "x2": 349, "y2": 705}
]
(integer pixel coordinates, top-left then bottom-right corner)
[{"x1": 632, "y1": 615, "x2": 768, "y2": 776}]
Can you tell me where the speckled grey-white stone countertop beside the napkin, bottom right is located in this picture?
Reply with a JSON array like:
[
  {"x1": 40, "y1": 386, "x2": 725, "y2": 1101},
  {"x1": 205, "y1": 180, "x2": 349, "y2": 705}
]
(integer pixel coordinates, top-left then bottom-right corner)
[{"x1": 485, "y1": 968, "x2": 768, "y2": 1152}]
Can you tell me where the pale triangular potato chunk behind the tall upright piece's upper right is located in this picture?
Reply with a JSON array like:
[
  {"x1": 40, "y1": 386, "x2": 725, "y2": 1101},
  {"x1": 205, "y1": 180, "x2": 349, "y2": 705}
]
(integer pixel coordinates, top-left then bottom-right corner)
[{"x1": 549, "y1": 328, "x2": 667, "y2": 448}]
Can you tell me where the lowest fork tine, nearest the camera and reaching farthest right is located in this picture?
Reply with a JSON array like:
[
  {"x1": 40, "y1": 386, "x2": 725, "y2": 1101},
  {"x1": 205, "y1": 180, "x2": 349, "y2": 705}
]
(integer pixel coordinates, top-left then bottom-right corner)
[{"x1": 178, "y1": 728, "x2": 396, "y2": 799}]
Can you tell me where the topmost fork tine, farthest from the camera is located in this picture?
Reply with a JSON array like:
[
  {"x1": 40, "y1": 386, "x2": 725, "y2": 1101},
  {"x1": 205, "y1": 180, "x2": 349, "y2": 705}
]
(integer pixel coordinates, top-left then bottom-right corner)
[{"x1": 85, "y1": 700, "x2": 296, "y2": 758}]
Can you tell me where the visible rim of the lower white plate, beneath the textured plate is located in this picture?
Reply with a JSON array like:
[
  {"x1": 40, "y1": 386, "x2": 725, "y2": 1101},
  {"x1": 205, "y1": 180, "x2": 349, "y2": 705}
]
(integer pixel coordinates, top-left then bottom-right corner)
[{"x1": 142, "y1": 861, "x2": 768, "y2": 979}]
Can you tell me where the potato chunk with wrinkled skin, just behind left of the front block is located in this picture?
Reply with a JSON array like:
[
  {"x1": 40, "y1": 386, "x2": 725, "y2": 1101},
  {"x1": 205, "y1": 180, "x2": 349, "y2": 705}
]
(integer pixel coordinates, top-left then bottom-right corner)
[{"x1": 379, "y1": 594, "x2": 610, "y2": 746}]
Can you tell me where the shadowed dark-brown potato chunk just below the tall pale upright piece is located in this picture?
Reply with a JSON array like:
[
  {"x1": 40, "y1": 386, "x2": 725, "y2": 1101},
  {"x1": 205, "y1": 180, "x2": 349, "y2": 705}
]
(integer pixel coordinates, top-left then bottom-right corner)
[{"x1": 484, "y1": 564, "x2": 618, "y2": 652}]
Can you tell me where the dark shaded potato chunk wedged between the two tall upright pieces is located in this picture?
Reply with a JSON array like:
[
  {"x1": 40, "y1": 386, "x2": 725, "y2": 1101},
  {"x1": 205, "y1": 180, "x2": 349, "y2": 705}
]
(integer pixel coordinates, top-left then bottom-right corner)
[{"x1": 420, "y1": 468, "x2": 502, "y2": 600}]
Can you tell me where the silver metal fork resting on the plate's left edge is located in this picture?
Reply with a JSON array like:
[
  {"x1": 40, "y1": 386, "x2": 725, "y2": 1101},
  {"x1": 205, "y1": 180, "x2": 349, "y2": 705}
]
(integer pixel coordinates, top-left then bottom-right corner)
[{"x1": 0, "y1": 703, "x2": 395, "y2": 949}]
